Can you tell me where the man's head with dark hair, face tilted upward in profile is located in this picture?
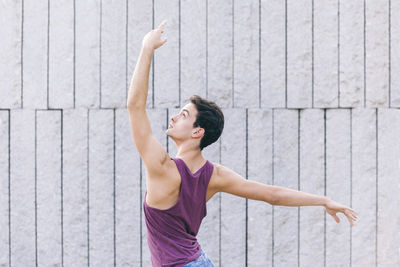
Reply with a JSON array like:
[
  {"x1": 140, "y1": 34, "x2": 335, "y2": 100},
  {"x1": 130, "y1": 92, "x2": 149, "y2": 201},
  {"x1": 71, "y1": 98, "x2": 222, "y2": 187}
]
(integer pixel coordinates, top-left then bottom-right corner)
[{"x1": 166, "y1": 95, "x2": 224, "y2": 150}]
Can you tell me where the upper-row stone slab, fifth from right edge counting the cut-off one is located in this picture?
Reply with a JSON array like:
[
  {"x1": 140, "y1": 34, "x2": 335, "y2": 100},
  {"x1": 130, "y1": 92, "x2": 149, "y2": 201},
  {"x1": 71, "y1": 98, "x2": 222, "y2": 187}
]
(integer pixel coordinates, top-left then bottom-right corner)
[{"x1": 288, "y1": 0, "x2": 312, "y2": 107}]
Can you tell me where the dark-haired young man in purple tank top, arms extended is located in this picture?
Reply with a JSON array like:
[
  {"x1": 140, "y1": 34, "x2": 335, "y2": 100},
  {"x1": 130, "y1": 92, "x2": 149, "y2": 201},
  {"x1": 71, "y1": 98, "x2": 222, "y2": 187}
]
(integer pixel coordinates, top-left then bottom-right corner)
[{"x1": 127, "y1": 21, "x2": 357, "y2": 266}]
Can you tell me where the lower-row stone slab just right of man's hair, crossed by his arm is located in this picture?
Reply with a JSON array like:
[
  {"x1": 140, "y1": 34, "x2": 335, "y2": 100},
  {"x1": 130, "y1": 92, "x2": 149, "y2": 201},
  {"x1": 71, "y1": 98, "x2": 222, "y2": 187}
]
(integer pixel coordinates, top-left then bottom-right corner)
[{"x1": 220, "y1": 108, "x2": 246, "y2": 267}]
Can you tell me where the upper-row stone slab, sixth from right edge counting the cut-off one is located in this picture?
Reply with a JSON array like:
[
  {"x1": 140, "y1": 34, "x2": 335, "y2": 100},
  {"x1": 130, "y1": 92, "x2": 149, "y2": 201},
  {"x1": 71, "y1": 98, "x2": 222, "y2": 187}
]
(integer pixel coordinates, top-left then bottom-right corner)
[{"x1": 260, "y1": 0, "x2": 286, "y2": 107}]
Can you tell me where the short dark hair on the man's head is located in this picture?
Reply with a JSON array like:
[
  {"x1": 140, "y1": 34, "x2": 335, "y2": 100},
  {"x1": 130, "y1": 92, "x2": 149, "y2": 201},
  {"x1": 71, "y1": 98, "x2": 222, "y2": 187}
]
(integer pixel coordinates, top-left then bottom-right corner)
[{"x1": 189, "y1": 95, "x2": 224, "y2": 150}]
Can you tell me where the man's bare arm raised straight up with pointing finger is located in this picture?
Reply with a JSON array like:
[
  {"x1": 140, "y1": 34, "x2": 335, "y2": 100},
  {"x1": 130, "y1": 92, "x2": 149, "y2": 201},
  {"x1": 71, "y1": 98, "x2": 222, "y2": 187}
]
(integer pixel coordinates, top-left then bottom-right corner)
[{"x1": 126, "y1": 21, "x2": 168, "y2": 176}]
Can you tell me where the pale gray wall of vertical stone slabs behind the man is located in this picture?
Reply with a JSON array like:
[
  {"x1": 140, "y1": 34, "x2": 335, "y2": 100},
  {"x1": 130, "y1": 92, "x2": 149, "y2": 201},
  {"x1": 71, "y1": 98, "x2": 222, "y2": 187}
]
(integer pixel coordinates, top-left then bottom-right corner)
[{"x1": 0, "y1": 0, "x2": 400, "y2": 266}]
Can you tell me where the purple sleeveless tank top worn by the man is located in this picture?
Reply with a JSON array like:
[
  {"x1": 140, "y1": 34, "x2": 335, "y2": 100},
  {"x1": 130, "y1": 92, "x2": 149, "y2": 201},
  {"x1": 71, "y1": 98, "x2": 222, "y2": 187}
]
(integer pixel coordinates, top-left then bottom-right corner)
[{"x1": 143, "y1": 158, "x2": 214, "y2": 267}]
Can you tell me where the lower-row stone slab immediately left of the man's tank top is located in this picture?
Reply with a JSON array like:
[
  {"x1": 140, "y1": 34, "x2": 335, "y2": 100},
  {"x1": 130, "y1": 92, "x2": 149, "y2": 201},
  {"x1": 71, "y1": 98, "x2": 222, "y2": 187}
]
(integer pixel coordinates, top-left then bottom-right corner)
[{"x1": 115, "y1": 109, "x2": 143, "y2": 266}]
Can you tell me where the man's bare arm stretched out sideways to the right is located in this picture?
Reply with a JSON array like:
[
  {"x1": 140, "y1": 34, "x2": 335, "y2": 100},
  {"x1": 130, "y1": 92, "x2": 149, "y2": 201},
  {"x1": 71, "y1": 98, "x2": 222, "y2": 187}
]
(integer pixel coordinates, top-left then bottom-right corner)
[{"x1": 215, "y1": 164, "x2": 357, "y2": 226}]
